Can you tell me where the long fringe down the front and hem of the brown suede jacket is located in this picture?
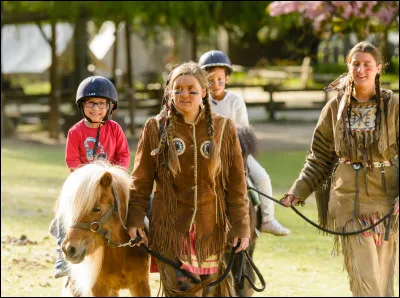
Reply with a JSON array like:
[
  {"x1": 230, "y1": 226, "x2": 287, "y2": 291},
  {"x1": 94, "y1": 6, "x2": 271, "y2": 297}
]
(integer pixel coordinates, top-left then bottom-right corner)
[{"x1": 150, "y1": 116, "x2": 238, "y2": 264}]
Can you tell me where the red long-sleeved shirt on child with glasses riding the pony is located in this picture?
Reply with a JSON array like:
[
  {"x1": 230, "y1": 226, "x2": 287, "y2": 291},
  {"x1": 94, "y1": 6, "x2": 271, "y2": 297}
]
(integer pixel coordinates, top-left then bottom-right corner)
[{"x1": 65, "y1": 119, "x2": 131, "y2": 169}]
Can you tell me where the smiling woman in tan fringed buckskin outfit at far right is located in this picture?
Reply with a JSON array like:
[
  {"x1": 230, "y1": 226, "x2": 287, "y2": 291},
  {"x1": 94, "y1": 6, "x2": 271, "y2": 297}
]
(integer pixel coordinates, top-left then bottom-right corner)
[{"x1": 282, "y1": 41, "x2": 399, "y2": 297}]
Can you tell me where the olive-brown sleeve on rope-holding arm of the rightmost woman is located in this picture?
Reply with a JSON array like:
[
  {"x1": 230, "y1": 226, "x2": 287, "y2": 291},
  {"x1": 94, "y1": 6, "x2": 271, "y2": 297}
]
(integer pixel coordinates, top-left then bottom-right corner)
[{"x1": 289, "y1": 99, "x2": 336, "y2": 200}]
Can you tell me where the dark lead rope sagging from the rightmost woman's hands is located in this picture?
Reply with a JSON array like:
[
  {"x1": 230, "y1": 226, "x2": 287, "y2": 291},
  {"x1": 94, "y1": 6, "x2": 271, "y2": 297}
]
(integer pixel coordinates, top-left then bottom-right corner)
[{"x1": 247, "y1": 186, "x2": 394, "y2": 241}]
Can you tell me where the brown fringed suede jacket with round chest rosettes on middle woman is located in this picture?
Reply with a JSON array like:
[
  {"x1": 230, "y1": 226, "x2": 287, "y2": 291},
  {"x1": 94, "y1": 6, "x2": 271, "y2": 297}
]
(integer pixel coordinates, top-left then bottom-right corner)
[{"x1": 127, "y1": 108, "x2": 250, "y2": 262}]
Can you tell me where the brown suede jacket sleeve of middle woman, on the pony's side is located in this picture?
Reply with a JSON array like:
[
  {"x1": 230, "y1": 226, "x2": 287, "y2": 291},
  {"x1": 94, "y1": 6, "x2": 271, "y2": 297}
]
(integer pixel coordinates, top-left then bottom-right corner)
[{"x1": 127, "y1": 118, "x2": 158, "y2": 228}]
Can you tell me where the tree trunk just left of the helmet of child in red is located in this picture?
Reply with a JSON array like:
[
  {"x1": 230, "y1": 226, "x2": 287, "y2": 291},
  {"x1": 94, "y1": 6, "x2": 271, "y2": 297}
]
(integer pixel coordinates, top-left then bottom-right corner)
[{"x1": 48, "y1": 19, "x2": 60, "y2": 140}]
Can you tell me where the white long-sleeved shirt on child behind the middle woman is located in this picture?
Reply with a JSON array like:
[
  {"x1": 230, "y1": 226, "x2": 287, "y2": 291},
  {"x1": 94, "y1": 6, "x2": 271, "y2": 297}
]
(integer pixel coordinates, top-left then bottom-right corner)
[{"x1": 211, "y1": 90, "x2": 249, "y2": 127}]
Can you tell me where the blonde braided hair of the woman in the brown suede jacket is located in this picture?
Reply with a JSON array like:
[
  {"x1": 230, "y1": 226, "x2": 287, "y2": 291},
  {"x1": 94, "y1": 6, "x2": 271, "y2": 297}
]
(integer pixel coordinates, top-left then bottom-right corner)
[{"x1": 151, "y1": 61, "x2": 220, "y2": 177}]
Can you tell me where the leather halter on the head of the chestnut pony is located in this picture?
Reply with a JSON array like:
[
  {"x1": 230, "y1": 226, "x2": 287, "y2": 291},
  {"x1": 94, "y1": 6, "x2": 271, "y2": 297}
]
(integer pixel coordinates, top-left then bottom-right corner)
[{"x1": 70, "y1": 187, "x2": 133, "y2": 247}]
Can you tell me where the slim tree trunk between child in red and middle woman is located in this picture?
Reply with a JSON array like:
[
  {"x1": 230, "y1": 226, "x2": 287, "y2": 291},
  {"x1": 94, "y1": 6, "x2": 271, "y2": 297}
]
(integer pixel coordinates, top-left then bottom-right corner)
[{"x1": 125, "y1": 21, "x2": 136, "y2": 137}]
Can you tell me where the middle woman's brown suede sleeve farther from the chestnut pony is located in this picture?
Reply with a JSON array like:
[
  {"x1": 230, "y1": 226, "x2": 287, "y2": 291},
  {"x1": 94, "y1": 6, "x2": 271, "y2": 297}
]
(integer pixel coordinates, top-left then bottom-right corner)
[{"x1": 221, "y1": 119, "x2": 250, "y2": 238}]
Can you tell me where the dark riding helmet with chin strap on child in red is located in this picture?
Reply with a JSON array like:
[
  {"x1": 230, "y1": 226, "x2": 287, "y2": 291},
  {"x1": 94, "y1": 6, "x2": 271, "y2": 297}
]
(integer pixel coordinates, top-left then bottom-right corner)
[{"x1": 76, "y1": 76, "x2": 118, "y2": 123}]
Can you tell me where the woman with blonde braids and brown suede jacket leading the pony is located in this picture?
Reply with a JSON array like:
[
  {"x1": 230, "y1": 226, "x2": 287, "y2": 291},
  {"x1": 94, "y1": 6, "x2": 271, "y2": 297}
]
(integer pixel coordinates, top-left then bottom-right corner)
[{"x1": 128, "y1": 62, "x2": 250, "y2": 296}]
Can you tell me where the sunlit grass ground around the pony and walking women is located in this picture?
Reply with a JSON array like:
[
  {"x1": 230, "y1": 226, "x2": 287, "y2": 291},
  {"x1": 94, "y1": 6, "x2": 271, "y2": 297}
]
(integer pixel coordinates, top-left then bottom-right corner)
[{"x1": 1, "y1": 139, "x2": 398, "y2": 297}]
